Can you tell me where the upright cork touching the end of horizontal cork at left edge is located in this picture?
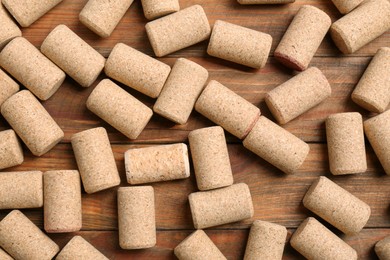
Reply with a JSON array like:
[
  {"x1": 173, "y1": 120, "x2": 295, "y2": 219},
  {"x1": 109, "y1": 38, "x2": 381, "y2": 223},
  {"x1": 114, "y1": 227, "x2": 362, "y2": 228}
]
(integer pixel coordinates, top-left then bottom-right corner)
[{"x1": 43, "y1": 171, "x2": 82, "y2": 233}]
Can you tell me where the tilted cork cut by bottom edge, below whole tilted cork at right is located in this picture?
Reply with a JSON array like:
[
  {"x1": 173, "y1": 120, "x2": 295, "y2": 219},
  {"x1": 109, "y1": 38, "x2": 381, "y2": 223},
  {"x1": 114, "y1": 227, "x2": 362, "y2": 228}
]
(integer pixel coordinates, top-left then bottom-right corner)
[{"x1": 290, "y1": 218, "x2": 357, "y2": 260}]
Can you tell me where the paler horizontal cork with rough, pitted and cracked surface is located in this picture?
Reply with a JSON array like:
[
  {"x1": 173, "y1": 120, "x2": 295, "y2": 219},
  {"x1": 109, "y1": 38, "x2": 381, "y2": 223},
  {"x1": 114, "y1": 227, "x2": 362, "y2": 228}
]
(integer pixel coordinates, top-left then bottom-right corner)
[{"x1": 125, "y1": 144, "x2": 190, "y2": 184}]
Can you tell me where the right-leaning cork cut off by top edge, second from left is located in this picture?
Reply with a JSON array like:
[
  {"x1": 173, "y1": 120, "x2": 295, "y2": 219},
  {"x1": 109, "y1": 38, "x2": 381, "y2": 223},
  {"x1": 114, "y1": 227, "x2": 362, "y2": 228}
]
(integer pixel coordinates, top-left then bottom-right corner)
[{"x1": 79, "y1": 0, "x2": 133, "y2": 38}]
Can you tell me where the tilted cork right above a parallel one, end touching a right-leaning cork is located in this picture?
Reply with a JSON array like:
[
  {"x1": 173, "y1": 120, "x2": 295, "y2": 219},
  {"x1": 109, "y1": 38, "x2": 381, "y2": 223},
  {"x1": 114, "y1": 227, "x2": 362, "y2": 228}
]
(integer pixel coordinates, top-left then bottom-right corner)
[{"x1": 104, "y1": 43, "x2": 171, "y2": 98}]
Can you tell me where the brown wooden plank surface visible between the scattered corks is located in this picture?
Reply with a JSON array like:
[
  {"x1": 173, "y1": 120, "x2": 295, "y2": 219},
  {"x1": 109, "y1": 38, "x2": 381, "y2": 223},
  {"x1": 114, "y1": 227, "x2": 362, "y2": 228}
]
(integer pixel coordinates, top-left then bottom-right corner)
[{"x1": 0, "y1": 0, "x2": 390, "y2": 259}]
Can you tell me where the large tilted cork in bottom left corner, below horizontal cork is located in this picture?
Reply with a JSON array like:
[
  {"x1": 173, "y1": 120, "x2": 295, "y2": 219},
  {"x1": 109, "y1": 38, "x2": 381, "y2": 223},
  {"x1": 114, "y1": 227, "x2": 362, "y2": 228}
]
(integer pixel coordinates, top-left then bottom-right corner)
[{"x1": 0, "y1": 210, "x2": 60, "y2": 260}]
